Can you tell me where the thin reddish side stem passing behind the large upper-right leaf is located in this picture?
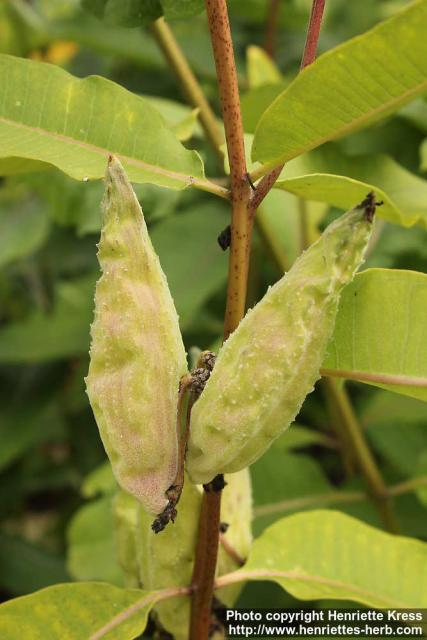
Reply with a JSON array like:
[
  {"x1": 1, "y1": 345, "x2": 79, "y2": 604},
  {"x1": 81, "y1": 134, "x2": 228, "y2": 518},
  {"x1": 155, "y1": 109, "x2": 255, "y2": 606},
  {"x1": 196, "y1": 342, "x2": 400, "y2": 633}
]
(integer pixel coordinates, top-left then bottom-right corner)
[{"x1": 247, "y1": 0, "x2": 326, "y2": 199}]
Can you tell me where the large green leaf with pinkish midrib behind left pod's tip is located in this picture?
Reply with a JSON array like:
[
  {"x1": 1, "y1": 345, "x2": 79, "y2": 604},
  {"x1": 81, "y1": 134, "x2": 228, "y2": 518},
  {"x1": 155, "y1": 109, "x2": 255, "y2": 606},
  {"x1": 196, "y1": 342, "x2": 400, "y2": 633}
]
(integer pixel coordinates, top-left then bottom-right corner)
[{"x1": 0, "y1": 55, "x2": 203, "y2": 189}]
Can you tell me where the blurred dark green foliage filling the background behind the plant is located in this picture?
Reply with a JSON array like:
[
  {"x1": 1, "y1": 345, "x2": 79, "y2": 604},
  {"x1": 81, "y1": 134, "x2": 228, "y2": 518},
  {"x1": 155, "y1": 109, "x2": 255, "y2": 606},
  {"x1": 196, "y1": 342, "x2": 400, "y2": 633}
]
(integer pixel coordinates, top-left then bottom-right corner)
[{"x1": 0, "y1": 0, "x2": 427, "y2": 607}]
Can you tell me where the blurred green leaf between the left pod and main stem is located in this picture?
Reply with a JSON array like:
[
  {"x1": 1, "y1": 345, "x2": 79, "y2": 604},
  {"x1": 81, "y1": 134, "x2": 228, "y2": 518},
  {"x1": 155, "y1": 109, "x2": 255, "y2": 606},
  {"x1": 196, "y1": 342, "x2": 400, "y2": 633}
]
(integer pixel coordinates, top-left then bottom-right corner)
[{"x1": 151, "y1": 202, "x2": 228, "y2": 329}]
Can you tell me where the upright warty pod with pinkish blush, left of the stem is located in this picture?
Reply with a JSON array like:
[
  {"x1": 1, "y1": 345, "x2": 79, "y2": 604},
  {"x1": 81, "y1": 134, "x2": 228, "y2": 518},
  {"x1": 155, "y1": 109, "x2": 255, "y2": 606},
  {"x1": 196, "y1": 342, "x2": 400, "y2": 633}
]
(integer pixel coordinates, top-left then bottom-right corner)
[{"x1": 86, "y1": 158, "x2": 187, "y2": 514}]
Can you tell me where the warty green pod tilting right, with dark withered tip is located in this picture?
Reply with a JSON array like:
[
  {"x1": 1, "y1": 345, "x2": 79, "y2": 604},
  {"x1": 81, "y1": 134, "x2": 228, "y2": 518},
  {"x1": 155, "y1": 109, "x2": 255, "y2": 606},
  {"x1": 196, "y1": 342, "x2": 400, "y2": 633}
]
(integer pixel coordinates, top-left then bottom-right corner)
[{"x1": 187, "y1": 194, "x2": 375, "y2": 484}]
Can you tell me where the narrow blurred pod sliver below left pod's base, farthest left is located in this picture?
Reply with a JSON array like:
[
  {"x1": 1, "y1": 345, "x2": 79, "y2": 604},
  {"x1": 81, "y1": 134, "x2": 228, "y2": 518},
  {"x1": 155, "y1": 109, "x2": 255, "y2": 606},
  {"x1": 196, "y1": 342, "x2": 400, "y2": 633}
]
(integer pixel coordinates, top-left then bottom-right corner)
[{"x1": 112, "y1": 489, "x2": 140, "y2": 588}]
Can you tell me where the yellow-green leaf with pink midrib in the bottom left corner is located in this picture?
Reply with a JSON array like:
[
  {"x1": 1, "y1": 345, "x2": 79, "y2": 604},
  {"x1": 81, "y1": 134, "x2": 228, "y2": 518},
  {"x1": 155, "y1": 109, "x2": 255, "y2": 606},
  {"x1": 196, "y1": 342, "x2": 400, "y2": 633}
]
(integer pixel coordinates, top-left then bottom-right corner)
[{"x1": 0, "y1": 582, "x2": 164, "y2": 640}]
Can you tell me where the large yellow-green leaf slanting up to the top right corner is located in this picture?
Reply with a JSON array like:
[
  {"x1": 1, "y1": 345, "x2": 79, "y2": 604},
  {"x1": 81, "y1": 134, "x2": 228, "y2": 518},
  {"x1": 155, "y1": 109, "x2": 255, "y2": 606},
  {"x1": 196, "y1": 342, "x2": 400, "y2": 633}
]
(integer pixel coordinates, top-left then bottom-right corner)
[{"x1": 252, "y1": 0, "x2": 427, "y2": 169}]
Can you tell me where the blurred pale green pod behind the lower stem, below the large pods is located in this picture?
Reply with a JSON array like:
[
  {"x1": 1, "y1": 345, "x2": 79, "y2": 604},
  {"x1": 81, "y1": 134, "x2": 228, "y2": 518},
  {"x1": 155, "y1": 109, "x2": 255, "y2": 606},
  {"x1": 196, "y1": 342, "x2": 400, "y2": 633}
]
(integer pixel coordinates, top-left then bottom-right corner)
[{"x1": 137, "y1": 469, "x2": 252, "y2": 640}]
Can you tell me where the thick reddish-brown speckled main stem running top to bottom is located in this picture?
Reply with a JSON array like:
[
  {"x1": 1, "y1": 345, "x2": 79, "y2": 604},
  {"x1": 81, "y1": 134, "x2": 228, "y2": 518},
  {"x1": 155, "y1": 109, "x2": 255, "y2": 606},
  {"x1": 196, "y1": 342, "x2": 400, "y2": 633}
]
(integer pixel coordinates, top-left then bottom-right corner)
[{"x1": 190, "y1": 0, "x2": 253, "y2": 640}]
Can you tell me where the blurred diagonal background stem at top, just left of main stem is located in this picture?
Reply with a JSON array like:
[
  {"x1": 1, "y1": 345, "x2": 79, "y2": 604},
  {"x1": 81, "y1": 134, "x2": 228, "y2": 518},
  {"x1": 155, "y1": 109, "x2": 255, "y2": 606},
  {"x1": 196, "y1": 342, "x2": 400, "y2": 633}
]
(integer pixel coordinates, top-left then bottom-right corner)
[{"x1": 151, "y1": 18, "x2": 224, "y2": 167}]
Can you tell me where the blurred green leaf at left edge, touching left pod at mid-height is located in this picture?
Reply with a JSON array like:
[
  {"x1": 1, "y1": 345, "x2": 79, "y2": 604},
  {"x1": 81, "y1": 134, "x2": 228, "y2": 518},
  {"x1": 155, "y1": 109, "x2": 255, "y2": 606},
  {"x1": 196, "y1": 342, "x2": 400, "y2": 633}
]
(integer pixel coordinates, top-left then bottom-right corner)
[{"x1": 0, "y1": 273, "x2": 97, "y2": 363}]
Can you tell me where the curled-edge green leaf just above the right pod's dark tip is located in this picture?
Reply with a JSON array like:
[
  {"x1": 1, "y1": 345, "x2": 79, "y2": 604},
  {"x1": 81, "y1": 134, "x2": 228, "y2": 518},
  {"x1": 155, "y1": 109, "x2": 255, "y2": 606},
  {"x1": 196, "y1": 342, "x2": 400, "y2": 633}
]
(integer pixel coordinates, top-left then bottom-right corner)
[{"x1": 275, "y1": 145, "x2": 427, "y2": 228}]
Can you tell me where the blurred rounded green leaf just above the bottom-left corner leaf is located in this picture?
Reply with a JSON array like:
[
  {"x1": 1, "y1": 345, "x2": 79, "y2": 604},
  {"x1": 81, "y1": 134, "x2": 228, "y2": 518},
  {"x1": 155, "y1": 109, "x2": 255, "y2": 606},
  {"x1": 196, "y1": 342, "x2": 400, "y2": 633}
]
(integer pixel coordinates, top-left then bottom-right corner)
[{"x1": 67, "y1": 496, "x2": 123, "y2": 587}]
